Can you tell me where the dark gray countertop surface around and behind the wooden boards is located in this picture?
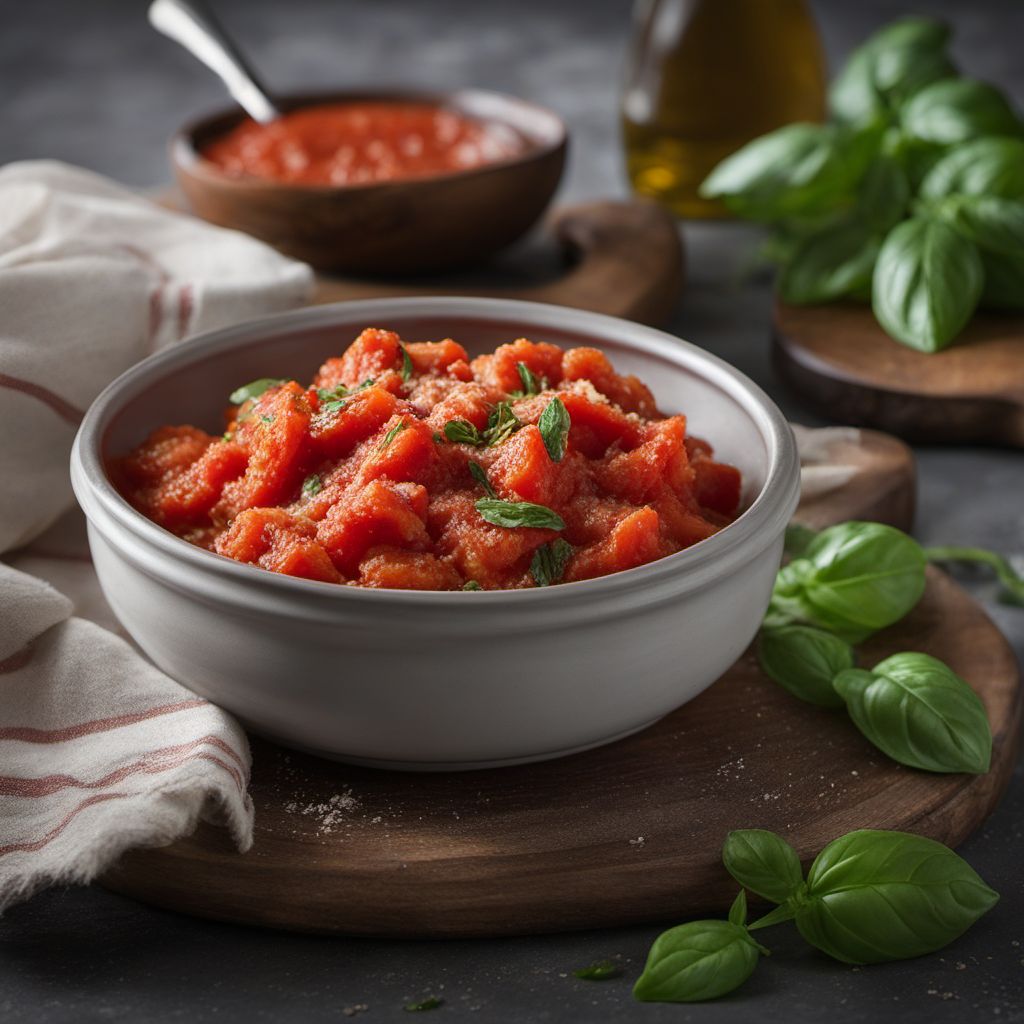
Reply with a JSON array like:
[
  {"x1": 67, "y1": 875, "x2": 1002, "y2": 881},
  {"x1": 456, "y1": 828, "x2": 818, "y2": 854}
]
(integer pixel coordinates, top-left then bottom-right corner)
[{"x1": 0, "y1": 0, "x2": 1024, "y2": 1024}]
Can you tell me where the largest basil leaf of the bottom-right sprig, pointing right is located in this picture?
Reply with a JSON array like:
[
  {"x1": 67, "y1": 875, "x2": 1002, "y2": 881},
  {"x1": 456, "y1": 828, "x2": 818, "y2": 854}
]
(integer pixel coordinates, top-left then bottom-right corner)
[{"x1": 796, "y1": 829, "x2": 999, "y2": 964}]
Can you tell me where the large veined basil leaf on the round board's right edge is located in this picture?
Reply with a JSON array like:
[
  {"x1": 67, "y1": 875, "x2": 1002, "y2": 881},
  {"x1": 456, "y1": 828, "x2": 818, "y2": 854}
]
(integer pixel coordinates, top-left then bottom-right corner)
[{"x1": 834, "y1": 653, "x2": 992, "y2": 775}]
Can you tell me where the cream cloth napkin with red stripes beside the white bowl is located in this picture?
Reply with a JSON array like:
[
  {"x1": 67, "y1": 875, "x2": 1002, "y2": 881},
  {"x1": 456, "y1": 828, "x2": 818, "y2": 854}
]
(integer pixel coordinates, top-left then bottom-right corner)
[{"x1": 0, "y1": 161, "x2": 312, "y2": 909}]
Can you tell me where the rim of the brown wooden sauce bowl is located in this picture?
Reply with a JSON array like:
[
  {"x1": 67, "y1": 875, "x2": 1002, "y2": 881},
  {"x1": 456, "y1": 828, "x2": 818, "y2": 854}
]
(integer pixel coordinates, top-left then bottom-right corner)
[{"x1": 170, "y1": 86, "x2": 569, "y2": 197}]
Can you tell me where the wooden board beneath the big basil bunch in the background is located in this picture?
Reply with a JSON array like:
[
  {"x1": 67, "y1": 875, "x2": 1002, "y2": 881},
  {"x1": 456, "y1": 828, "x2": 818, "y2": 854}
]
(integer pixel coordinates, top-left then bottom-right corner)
[{"x1": 774, "y1": 303, "x2": 1024, "y2": 447}]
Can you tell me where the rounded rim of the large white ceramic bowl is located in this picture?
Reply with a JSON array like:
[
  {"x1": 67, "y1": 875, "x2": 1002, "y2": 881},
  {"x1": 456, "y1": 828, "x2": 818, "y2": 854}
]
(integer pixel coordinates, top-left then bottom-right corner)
[{"x1": 71, "y1": 296, "x2": 800, "y2": 613}]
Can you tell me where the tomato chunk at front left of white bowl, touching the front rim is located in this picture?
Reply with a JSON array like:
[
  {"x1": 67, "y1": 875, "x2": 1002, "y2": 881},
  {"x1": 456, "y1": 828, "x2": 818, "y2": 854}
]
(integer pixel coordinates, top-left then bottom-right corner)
[{"x1": 215, "y1": 508, "x2": 341, "y2": 583}]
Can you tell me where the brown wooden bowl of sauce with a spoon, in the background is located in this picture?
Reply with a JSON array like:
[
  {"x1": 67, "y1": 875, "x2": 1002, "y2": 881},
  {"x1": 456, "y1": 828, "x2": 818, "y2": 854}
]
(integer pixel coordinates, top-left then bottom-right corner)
[{"x1": 171, "y1": 89, "x2": 566, "y2": 274}]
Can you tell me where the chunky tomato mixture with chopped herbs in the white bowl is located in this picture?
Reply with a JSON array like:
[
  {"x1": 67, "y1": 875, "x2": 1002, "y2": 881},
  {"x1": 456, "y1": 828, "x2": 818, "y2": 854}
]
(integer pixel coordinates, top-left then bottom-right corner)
[{"x1": 113, "y1": 329, "x2": 740, "y2": 590}]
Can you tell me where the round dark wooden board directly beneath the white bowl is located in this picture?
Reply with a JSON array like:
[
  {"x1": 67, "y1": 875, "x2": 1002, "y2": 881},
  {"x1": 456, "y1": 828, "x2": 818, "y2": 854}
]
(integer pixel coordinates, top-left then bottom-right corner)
[{"x1": 104, "y1": 430, "x2": 1022, "y2": 937}]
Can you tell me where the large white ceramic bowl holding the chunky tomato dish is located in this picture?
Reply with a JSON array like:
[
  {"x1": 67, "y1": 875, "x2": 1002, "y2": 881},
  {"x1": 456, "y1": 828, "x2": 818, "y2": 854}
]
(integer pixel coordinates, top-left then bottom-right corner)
[{"x1": 72, "y1": 298, "x2": 800, "y2": 769}]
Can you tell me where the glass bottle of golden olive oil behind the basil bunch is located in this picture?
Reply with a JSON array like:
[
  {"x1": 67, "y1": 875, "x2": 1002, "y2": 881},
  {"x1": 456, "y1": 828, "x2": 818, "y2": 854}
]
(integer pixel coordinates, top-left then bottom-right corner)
[{"x1": 622, "y1": 0, "x2": 825, "y2": 217}]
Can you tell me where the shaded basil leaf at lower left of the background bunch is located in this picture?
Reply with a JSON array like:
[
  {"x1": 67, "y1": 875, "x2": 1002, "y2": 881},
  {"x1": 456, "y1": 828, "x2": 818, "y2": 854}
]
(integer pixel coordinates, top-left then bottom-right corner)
[{"x1": 779, "y1": 221, "x2": 881, "y2": 305}]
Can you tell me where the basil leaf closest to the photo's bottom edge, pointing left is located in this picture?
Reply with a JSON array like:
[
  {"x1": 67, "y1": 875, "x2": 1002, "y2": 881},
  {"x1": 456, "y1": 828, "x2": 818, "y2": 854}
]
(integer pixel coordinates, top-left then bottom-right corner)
[{"x1": 633, "y1": 896, "x2": 767, "y2": 1002}]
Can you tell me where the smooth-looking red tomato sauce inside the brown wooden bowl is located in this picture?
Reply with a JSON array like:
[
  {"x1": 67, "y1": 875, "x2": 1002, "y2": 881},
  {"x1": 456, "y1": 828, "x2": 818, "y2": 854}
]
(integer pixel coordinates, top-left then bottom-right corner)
[{"x1": 203, "y1": 102, "x2": 525, "y2": 185}]
